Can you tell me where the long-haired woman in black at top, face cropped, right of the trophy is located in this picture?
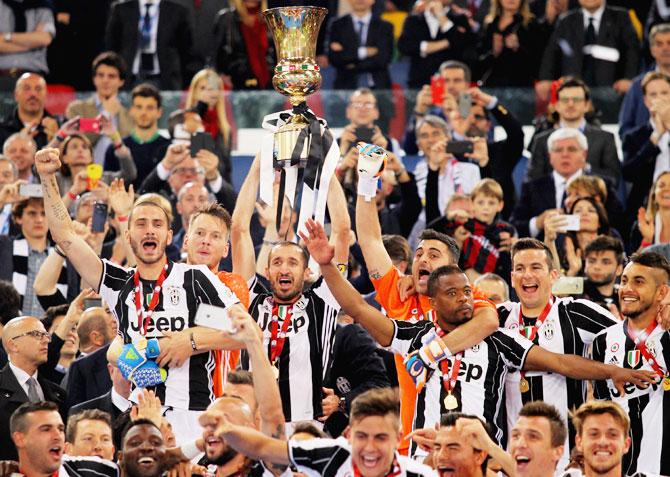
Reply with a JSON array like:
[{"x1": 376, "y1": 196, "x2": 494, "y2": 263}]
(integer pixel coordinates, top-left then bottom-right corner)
[{"x1": 477, "y1": 0, "x2": 547, "y2": 87}]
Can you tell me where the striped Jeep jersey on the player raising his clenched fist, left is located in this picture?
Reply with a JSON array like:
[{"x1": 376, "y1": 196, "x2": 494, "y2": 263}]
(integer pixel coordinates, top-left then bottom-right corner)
[{"x1": 99, "y1": 260, "x2": 239, "y2": 411}]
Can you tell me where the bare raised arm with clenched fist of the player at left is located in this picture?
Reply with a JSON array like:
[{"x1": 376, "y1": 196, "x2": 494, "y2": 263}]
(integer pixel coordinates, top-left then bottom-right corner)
[{"x1": 35, "y1": 148, "x2": 102, "y2": 291}]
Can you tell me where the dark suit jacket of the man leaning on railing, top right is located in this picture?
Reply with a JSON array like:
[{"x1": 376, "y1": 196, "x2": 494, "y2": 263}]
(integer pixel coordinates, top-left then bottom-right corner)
[{"x1": 539, "y1": 7, "x2": 640, "y2": 87}]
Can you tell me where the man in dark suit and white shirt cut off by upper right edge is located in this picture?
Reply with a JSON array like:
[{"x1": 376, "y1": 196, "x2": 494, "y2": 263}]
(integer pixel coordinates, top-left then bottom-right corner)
[{"x1": 622, "y1": 71, "x2": 670, "y2": 221}]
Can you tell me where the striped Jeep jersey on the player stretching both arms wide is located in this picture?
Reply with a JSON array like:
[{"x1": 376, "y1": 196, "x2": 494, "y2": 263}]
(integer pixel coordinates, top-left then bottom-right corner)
[{"x1": 391, "y1": 320, "x2": 533, "y2": 455}]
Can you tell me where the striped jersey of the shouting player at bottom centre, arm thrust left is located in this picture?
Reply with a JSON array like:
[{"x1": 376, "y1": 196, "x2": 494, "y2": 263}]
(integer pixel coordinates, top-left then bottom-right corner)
[{"x1": 288, "y1": 437, "x2": 437, "y2": 477}]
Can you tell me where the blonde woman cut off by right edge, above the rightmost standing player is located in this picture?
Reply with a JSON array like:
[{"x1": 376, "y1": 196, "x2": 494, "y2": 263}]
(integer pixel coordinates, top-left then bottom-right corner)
[{"x1": 628, "y1": 171, "x2": 670, "y2": 252}]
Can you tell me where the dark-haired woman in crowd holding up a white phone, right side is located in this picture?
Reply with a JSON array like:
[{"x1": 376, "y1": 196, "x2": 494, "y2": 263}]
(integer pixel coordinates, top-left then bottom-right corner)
[{"x1": 544, "y1": 197, "x2": 620, "y2": 277}]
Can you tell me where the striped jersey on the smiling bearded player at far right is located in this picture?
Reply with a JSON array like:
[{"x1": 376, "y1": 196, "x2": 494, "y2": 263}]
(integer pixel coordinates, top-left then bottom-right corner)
[{"x1": 593, "y1": 320, "x2": 670, "y2": 475}]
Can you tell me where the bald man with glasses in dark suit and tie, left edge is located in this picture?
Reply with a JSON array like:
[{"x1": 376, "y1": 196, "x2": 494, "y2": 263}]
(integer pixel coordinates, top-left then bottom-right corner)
[{"x1": 0, "y1": 316, "x2": 65, "y2": 460}]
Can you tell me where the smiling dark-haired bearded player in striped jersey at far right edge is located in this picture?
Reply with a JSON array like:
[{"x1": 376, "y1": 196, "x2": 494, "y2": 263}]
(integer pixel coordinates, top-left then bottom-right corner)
[{"x1": 584, "y1": 252, "x2": 670, "y2": 475}]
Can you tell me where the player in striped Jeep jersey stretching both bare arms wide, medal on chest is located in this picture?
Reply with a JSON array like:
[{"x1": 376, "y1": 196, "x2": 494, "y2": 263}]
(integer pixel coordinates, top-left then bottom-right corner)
[{"x1": 302, "y1": 221, "x2": 651, "y2": 454}]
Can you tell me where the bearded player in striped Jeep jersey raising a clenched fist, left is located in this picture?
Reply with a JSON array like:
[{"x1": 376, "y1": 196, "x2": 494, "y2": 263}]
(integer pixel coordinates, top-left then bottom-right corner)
[{"x1": 35, "y1": 148, "x2": 245, "y2": 439}]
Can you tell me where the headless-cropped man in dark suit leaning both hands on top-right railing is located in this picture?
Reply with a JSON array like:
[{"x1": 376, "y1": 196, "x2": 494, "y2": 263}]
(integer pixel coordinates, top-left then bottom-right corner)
[{"x1": 536, "y1": 0, "x2": 640, "y2": 97}]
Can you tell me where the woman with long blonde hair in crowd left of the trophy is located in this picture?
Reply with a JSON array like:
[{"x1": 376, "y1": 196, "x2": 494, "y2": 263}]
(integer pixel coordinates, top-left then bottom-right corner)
[{"x1": 185, "y1": 68, "x2": 233, "y2": 182}]
